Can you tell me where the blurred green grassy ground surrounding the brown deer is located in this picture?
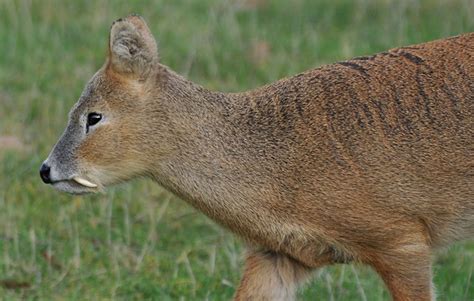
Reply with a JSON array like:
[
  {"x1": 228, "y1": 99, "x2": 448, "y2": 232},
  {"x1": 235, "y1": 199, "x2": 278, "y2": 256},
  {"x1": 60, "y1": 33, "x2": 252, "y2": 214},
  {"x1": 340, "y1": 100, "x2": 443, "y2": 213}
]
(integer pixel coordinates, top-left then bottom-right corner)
[{"x1": 0, "y1": 0, "x2": 474, "y2": 301}]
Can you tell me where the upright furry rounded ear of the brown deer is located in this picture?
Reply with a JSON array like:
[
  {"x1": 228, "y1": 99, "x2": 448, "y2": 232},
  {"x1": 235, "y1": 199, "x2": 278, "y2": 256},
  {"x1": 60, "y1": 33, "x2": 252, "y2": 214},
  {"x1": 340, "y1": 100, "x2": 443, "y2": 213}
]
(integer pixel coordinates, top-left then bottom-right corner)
[{"x1": 109, "y1": 15, "x2": 158, "y2": 79}]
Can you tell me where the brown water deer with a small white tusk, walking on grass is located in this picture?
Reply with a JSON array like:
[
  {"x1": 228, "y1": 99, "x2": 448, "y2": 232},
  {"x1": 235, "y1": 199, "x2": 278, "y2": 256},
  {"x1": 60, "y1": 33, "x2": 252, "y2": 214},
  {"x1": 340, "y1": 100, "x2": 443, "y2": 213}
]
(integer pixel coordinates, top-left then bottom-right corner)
[{"x1": 40, "y1": 15, "x2": 474, "y2": 301}]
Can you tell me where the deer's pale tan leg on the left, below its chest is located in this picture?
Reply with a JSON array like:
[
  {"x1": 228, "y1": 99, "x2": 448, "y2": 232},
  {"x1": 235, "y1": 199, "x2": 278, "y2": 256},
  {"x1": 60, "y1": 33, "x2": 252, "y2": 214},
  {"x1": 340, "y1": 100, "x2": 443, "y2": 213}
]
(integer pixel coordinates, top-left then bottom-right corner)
[{"x1": 234, "y1": 251, "x2": 311, "y2": 301}]
